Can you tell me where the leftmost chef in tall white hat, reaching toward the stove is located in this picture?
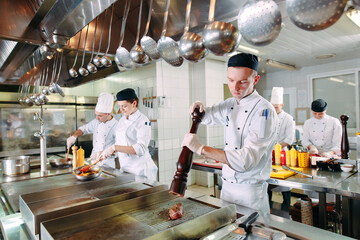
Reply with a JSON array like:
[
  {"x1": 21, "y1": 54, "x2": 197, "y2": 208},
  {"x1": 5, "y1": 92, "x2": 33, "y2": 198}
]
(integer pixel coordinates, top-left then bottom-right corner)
[{"x1": 66, "y1": 92, "x2": 117, "y2": 168}]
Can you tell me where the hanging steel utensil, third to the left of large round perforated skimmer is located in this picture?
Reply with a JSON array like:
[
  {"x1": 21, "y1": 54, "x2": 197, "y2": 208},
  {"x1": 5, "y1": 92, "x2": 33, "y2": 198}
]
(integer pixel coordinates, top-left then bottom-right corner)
[{"x1": 157, "y1": 0, "x2": 184, "y2": 67}]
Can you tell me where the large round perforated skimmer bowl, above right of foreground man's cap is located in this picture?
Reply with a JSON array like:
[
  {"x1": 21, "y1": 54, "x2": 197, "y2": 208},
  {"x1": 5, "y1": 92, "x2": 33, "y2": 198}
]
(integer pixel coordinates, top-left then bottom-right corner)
[{"x1": 238, "y1": 0, "x2": 281, "y2": 46}]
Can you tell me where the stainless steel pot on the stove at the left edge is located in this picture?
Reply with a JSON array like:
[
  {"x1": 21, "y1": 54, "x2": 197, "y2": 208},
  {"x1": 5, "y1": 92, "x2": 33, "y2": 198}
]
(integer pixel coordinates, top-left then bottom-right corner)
[{"x1": 1, "y1": 156, "x2": 30, "y2": 176}]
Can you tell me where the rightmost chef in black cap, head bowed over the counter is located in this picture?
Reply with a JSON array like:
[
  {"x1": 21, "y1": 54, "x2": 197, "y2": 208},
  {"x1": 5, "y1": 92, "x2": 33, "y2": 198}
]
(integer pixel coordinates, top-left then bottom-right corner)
[{"x1": 301, "y1": 99, "x2": 342, "y2": 158}]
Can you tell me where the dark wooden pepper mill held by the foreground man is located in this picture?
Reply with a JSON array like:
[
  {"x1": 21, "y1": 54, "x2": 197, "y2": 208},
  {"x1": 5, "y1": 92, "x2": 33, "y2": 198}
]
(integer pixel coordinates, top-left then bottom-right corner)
[{"x1": 169, "y1": 108, "x2": 205, "y2": 196}]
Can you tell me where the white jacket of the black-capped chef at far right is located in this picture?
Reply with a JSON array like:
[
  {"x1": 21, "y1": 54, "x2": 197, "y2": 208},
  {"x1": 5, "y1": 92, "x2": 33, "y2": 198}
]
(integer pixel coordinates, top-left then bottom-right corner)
[{"x1": 301, "y1": 114, "x2": 342, "y2": 155}]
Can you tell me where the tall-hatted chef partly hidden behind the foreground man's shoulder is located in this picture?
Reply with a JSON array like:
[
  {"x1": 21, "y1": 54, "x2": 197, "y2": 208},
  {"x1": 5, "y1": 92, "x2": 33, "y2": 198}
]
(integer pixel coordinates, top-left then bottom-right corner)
[{"x1": 268, "y1": 87, "x2": 295, "y2": 211}]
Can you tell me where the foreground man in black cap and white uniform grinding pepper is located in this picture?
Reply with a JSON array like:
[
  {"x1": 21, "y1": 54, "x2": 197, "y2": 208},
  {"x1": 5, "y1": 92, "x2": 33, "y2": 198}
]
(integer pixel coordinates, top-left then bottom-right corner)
[{"x1": 182, "y1": 53, "x2": 277, "y2": 213}]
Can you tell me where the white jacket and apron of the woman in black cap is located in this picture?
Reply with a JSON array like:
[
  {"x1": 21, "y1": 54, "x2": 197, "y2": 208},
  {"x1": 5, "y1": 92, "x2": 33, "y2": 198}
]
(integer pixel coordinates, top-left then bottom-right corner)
[{"x1": 115, "y1": 110, "x2": 157, "y2": 180}]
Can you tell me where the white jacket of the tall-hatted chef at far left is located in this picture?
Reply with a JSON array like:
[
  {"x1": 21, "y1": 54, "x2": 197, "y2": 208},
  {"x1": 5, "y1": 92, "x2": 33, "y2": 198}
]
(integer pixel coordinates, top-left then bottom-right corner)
[{"x1": 79, "y1": 118, "x2": 117, "y2": 168}]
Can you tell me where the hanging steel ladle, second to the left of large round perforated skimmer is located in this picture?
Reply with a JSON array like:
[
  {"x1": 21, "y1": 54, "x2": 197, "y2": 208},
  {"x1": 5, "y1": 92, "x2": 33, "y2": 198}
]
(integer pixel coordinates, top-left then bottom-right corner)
[{"x1": 179, "y1": 0, "x2": 209, "y2": 62}]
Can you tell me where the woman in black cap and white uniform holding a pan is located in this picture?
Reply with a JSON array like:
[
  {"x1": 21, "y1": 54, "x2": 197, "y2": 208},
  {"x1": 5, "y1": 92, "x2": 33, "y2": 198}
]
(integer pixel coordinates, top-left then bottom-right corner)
[{"x1": 101, "y1": 88, "x2": 157, "y2": 180}]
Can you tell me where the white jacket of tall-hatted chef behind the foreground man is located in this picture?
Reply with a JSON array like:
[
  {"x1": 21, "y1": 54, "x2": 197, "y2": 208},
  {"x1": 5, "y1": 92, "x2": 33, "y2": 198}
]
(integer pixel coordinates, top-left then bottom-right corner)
[{"x1": 276, "y1": 111, "x2": 295, "y2": 145}]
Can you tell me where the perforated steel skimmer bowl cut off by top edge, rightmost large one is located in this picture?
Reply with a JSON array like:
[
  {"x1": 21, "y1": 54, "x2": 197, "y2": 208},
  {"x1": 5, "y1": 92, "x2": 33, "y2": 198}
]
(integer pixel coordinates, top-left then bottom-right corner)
[{"x1": 286, "y1": 0, "x2": 347, "y2": 31}]
